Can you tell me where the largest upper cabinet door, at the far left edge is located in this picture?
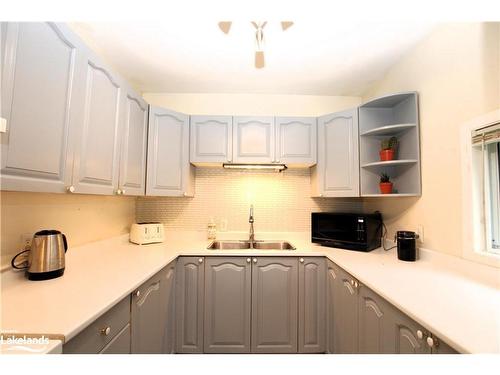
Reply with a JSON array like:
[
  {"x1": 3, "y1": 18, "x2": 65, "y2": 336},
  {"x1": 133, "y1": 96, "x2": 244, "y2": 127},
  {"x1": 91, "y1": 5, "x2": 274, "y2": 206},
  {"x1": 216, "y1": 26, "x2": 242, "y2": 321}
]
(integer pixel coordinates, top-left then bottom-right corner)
[{"x1": 0, "y1": 22, "x2": 84, "y2": 193}]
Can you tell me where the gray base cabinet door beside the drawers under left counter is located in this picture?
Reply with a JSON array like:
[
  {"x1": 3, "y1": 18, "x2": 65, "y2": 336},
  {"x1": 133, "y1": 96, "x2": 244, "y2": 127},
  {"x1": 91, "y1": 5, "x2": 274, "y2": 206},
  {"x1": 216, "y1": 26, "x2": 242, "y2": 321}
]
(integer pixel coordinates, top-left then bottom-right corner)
[{"x1": 131, "y1": 269, "x2": 167, "y2": 354}]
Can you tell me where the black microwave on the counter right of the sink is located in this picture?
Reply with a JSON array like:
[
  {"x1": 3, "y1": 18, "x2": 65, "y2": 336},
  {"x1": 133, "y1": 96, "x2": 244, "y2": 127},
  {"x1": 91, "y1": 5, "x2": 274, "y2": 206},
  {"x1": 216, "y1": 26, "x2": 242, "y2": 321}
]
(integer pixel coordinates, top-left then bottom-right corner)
[{"x1": 311, "y1": 212, "x2": 382, "y2": 251}]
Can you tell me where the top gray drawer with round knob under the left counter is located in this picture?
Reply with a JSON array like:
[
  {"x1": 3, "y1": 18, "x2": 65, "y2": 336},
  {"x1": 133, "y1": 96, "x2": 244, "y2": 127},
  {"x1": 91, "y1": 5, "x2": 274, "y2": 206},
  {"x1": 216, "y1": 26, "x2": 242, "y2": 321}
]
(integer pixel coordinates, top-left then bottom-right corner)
[{"x1": 63, "y1": 296, "x2": 130, "y2": 354}]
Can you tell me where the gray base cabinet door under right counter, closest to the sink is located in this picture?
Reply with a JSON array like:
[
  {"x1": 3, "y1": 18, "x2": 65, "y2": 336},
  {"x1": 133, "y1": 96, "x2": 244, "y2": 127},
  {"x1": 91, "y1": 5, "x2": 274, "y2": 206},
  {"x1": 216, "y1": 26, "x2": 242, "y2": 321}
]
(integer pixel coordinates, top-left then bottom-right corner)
[{"x1": 333, "y1": 266, "x2": 358, "y2": 354}]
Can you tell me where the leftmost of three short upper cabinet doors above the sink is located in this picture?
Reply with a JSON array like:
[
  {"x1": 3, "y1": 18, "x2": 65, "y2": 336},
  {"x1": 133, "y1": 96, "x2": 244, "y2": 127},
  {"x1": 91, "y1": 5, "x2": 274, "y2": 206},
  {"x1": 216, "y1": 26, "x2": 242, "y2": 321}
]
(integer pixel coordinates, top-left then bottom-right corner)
[{"x1": 190, "y1": 116, "x2": 233, "y2": 164}]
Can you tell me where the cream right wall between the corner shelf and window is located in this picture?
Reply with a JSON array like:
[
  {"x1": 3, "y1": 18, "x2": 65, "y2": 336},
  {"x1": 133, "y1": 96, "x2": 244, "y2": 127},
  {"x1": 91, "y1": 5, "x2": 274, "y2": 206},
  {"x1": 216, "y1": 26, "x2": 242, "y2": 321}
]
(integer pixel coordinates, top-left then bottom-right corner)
[{"x1": 364, "y1": 23, "x2": 500, "y2": 256}]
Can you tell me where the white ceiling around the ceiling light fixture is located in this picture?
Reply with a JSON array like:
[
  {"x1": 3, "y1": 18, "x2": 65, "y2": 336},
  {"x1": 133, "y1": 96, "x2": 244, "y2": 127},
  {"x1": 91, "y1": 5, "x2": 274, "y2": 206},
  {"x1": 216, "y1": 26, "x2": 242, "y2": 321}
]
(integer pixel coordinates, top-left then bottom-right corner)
[{"x1": 70, "y1": 1, "x2": 436, "y2": 96}]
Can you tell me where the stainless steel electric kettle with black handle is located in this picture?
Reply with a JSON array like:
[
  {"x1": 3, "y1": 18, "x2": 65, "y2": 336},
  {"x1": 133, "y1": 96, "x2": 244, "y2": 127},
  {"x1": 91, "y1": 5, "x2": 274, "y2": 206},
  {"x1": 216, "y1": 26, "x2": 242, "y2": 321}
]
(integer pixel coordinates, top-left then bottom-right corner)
[{"x1": 11, "y1": 229, "x2": 68, "y2": 280}]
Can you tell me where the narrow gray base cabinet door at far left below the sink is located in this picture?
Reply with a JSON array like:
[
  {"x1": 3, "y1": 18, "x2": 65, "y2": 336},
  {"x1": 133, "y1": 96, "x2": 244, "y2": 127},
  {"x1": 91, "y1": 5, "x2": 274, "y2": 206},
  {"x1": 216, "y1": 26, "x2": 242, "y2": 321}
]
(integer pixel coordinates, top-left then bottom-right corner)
[{"x1": 175, "y1": 257, "x2": 205, "y2": 353}]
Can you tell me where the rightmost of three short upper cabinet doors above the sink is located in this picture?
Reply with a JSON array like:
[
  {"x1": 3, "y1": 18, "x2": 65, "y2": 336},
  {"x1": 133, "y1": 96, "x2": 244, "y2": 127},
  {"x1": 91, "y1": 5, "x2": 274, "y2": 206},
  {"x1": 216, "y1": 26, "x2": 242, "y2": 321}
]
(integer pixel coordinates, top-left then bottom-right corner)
[{"x1": 276, "y1": 117, "x2": 317, "y2": 166}]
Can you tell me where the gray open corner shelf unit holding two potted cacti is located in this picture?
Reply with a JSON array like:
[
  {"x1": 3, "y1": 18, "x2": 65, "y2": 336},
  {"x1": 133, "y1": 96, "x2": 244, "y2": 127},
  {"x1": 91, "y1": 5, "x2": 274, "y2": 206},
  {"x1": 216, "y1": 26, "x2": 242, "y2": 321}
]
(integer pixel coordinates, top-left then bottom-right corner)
[{"x1": 359, "y1": 92, "x2": 421, "y2": 197}]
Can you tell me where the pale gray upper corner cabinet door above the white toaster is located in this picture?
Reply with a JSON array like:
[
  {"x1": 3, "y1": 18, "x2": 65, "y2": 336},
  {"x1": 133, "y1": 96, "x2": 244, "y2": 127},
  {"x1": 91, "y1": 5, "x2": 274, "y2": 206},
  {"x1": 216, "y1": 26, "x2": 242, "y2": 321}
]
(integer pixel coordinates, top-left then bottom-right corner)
[{"x1": 146, "y1": 106, "x2": 194, "y2": 196}]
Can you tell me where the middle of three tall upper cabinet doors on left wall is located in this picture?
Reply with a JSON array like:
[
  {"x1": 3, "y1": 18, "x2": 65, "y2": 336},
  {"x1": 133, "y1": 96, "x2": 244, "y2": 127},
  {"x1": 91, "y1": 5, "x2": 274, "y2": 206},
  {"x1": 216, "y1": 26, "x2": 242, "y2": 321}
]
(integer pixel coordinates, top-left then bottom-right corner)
[{"x1": 73, "y1": 50, "x2": 123, "y2": 195}]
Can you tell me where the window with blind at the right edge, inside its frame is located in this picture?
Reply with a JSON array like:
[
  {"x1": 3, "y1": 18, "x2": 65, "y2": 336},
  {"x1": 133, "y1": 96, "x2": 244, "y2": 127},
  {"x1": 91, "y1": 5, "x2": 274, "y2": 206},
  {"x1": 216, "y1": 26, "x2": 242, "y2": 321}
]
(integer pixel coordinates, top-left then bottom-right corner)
[{"x1": 471, "y1": 122, "x2": 500, "y2": 257}]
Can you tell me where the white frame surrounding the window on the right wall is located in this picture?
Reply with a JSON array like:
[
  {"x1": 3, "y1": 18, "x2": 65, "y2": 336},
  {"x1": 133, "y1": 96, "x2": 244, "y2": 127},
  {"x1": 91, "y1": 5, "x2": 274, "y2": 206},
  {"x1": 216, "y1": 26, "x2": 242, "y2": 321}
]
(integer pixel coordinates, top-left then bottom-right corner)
[{"x1": 460, "y1": 109, "x2": 500, "y2": 268}]
